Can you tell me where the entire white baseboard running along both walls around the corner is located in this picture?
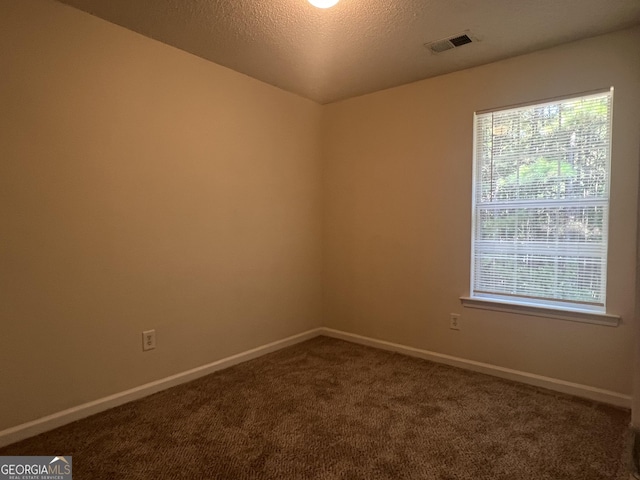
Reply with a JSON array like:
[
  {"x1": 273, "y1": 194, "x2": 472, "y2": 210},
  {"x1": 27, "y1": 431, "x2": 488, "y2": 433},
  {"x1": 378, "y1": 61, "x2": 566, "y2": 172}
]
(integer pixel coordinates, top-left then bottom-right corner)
[{"x1": 0, "y1": 327, "x2": 631, "y2": 447}]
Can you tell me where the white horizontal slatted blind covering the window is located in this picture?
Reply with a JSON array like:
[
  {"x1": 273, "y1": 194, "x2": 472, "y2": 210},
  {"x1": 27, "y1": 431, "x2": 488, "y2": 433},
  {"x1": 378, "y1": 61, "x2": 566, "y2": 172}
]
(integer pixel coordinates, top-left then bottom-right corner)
[{"x1": 471, "y1": 91, "x2": 612, "y2": 311}]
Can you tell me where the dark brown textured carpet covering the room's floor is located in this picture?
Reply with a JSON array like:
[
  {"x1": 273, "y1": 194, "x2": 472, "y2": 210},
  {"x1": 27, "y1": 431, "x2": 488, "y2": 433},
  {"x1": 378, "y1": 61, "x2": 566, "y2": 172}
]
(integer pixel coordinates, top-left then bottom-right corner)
[{"x1": 0, "y1": 337, "x2": 629, "y2": 480}]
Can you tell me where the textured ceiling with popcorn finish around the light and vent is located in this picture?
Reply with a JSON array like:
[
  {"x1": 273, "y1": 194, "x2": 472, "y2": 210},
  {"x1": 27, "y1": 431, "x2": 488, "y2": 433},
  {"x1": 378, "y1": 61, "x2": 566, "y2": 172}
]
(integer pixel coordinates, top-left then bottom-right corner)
[{"x1": 60, "y1": 0, "x2": 640, "y2": 103}]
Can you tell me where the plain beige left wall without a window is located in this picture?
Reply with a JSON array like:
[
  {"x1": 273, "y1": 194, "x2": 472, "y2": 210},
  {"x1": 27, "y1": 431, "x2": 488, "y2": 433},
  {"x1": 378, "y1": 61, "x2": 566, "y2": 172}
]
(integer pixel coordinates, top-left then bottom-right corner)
[{"x1": 0, "y1": 0, "x2": 321, "y2": 430}]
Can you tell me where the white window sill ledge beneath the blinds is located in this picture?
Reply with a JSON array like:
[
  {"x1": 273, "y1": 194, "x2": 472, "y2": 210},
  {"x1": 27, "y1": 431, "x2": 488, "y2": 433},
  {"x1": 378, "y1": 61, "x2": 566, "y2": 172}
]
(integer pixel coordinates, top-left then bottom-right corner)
[{"x1": 460, "y1": 297, "x2": 620, "y2": 327}]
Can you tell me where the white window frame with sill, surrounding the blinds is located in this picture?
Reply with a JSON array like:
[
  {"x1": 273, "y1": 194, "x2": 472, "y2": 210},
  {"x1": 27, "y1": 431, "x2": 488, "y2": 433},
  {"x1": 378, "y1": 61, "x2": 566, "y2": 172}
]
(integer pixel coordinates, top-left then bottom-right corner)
[{"x1": 460, "y1": 87, "x2": 620, "y2": 326}]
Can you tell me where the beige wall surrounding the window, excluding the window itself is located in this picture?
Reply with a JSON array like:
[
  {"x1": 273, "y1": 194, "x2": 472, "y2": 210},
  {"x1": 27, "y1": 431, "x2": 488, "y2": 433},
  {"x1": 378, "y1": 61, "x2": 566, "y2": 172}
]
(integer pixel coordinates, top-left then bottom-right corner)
[{"x1": 323, "y1": 29, "x2": 640, "y2": 394}]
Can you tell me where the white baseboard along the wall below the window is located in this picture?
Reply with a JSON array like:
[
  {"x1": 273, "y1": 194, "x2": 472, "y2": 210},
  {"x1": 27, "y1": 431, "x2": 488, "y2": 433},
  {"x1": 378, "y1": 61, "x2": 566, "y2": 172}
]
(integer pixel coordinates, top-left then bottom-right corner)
[{"x1": 320, "y1": 328, "x2": 631, "y2": 408}]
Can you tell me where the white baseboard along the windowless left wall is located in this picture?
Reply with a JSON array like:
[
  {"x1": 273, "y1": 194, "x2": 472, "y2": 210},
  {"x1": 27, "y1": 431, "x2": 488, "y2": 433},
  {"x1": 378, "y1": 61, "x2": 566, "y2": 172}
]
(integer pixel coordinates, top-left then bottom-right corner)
[{"x1": 0, "y1": 328, "x2": 322, "y2": 447}]
